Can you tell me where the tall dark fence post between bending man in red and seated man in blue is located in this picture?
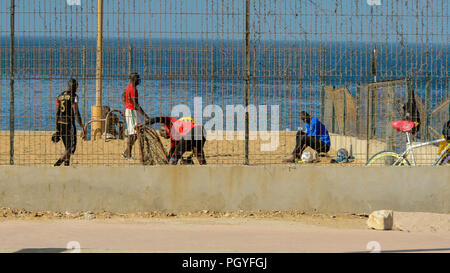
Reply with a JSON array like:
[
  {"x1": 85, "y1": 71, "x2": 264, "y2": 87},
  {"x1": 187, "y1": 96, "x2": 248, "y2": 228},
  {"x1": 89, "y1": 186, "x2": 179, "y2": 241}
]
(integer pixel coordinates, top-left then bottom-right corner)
[{"x1": 244, "y1": 0, "x2": 250, "y2": 165}]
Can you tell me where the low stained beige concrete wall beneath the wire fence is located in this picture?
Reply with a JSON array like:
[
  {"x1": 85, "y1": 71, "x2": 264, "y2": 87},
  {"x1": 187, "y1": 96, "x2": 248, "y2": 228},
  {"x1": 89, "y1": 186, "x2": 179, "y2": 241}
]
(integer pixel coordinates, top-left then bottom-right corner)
[{"x1": 0, "y1": 165, "x2": 450, "y2": 213}]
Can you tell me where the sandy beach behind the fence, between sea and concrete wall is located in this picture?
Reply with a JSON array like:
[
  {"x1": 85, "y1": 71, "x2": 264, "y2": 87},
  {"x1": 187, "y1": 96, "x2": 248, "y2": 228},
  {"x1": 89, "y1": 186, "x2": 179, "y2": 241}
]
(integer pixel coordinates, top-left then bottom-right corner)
[{"x1": 0, "y1": 131, "x2": 437, "y2": 166}]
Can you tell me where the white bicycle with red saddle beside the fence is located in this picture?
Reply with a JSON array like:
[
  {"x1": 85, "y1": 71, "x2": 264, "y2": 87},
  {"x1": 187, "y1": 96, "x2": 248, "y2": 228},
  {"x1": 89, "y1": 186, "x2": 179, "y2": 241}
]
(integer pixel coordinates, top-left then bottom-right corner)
[{"x1": 366, "y1": 120, "x2": 450, "y2": 166}]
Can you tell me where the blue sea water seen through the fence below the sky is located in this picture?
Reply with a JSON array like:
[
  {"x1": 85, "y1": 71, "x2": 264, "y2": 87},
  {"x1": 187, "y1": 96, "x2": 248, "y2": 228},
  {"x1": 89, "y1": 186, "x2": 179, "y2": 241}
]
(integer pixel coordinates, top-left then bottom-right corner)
[{"x1": 0, "y1": 37, "x2": 449, "y2": 130}]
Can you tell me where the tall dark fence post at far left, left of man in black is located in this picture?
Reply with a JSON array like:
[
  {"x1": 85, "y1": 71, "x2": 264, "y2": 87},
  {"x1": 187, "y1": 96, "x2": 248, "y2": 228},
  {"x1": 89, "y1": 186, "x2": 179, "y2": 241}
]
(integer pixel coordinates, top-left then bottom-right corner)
[{"x1": 9, "y1": 0, "x2": 15, "y2": 165}]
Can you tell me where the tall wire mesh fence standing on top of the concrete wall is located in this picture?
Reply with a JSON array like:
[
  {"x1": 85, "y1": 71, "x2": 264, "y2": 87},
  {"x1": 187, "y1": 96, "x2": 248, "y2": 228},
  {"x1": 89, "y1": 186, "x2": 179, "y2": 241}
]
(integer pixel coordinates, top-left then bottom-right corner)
[{"x1": 0, "y1": 0, "x2": 450, "y2": 165}]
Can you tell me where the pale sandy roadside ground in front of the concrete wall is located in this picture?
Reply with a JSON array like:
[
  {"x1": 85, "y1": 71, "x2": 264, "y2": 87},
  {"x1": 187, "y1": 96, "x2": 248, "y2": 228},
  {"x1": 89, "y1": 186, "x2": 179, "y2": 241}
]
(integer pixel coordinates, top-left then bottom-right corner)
[{"x1": 0, "y1": 208, "x2": 450, "y2": 253}]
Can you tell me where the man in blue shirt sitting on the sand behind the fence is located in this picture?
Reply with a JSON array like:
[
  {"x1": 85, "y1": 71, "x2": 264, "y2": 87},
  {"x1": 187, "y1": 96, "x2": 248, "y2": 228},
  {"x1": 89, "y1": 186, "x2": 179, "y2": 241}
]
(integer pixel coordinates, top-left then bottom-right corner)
[{"x1": 285, "y1": 111, "x2": 330, "y2": 163}]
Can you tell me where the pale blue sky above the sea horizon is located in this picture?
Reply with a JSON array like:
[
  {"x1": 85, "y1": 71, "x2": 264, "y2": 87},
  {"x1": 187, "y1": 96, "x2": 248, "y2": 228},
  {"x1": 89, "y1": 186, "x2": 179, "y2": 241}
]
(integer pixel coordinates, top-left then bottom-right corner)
[{"x1": 0, "y1": 0, "x2": 449, "y2": 44}]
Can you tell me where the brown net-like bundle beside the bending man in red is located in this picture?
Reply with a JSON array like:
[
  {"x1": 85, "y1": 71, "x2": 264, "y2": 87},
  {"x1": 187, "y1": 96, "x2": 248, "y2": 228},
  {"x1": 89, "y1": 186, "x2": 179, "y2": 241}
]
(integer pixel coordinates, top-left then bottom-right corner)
[{"x1": 139, "y1": 128, "x2": 168, "y2": 165}]
